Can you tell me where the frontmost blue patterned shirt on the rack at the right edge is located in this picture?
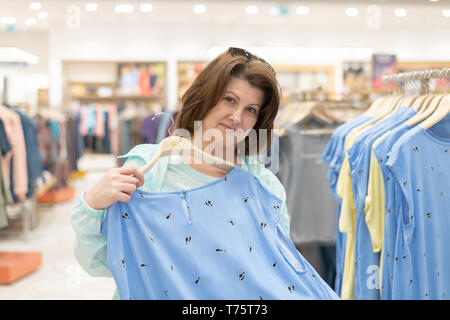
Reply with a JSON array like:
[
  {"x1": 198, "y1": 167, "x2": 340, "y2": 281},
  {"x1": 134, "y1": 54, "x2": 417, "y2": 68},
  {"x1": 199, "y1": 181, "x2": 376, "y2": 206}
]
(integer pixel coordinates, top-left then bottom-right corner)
[{"x1": 386, "y1": 114, "x2": 450, "y2": 299}]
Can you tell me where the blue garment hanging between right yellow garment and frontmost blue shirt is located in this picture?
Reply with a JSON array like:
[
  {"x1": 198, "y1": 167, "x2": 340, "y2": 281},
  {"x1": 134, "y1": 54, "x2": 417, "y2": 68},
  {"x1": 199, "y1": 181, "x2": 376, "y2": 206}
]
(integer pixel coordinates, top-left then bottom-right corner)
[{"x1": 372, "y1": 123, "x2": 418, "y2": 300}]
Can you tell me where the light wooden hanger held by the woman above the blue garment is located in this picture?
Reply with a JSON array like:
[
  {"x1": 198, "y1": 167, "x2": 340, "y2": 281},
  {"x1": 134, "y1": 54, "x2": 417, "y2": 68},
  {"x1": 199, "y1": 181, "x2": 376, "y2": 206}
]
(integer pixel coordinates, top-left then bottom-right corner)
[{"x1": 141, "y1": 136, "x2": 234, "y2": 174}]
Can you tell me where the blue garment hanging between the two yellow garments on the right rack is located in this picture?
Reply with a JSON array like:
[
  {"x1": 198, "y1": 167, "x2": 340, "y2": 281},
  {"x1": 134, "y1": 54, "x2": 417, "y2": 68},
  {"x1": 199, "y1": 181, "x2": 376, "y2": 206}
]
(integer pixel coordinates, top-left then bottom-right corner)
[{"x1": 348, "y1": 107, "x2": 417, "y2": 300}]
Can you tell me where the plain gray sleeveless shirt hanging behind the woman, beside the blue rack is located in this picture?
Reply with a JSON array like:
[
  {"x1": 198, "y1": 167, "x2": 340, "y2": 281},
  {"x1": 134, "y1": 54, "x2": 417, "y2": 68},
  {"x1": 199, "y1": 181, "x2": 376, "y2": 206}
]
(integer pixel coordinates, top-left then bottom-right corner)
[{"x1": 277, "y1": 118, "x2": 337, "y2": 244}]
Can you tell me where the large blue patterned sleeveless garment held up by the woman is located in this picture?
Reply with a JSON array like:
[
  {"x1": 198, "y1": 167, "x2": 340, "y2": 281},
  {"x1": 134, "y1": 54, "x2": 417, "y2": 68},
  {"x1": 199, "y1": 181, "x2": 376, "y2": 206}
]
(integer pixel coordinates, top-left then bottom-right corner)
[{"x1": 102, "y1": 166, "x2": 338, "y2": 300}]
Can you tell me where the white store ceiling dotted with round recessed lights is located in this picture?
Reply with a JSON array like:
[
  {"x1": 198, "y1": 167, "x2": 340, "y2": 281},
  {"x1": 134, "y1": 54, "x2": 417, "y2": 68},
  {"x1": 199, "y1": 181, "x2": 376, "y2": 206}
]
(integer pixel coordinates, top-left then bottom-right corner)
[{"x1": 0, "y1": 0, "x2": 450, "y2": 31}]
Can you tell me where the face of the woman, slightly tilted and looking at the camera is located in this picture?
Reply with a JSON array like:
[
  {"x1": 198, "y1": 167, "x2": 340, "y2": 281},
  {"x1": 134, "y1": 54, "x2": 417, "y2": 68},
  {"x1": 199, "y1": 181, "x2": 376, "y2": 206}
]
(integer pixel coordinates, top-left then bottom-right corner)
[{"x1": 202, "y1": 77, "x2": 264, "y2": 152}]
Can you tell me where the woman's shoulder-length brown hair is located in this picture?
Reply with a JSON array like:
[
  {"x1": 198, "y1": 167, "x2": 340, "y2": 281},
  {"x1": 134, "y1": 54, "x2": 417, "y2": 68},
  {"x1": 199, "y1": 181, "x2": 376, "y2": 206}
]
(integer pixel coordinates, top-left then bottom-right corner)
[{"x1": 176, "y1": 51, "x2": 281, "y2": 156}]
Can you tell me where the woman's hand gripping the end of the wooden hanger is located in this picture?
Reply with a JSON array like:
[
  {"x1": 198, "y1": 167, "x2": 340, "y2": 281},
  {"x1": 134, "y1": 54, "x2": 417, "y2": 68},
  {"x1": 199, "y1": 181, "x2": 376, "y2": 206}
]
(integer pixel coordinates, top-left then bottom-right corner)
[{"x1": 84, "y1": 167, "x2": 144, "y2": 210}]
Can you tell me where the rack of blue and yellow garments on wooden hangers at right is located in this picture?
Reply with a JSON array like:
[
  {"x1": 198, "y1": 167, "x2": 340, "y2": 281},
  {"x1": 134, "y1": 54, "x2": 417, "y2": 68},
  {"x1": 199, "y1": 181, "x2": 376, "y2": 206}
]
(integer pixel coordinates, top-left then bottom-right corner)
[{"x1": 323, "y1": 71, "x2": 450, "y2": 299}]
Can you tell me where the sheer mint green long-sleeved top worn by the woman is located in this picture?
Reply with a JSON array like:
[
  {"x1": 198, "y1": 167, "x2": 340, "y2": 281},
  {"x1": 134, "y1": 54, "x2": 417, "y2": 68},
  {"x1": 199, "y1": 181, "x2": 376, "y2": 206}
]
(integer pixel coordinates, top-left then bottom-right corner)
[{"x1": 70, "y1": 144, "x2": 290, "y2": 299}]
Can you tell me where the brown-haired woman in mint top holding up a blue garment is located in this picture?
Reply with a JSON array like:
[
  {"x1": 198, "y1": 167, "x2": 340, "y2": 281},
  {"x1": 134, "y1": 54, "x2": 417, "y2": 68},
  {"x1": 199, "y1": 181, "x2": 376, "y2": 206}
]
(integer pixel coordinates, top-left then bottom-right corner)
[{"x1": 71, "y1": 48, "x2": 310, "y2": 299}]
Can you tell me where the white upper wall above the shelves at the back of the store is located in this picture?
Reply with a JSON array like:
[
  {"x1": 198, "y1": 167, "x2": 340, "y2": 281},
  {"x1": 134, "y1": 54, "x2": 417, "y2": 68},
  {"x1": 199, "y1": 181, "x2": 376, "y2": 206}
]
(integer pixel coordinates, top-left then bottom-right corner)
[{"x1": 0, "y1": 23, "x2": 450, "y2": 108}]
